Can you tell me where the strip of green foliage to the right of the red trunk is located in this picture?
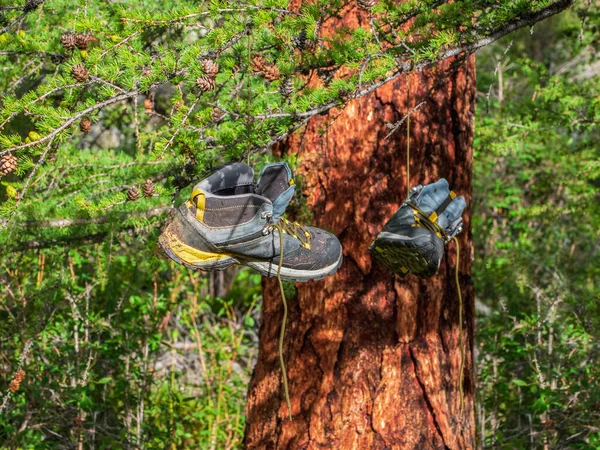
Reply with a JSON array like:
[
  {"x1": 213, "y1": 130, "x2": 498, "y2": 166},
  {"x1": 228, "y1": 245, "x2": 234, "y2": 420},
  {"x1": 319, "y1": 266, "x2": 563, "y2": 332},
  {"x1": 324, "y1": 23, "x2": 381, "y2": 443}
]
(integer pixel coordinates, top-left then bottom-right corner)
[{"x1": 473, "y1": 5, "x2": 600, "y2": 450}]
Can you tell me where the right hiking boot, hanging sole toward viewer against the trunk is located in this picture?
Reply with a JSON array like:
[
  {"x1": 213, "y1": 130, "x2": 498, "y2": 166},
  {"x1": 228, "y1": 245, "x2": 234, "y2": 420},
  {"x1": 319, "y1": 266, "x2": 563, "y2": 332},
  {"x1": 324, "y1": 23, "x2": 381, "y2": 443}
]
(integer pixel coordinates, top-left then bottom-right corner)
[{"x1": 369, "y1": 178, "x2": 467, "y2": 278}]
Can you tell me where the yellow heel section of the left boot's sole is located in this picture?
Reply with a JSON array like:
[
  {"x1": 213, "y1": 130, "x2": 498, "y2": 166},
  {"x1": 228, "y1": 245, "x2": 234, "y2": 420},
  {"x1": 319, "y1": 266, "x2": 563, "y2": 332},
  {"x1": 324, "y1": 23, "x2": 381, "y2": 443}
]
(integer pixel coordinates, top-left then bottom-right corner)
[{"x1": 158, "y1": 232, "x2": 238, "y2": 271}]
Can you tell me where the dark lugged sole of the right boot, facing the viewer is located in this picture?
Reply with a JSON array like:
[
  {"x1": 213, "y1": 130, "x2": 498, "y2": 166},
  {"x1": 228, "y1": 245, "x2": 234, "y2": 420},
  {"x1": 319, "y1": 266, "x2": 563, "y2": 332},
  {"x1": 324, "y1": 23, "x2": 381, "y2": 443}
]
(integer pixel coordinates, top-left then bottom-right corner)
[{"x1": 369, "y1": 232, "x2": 438, "y2": 278}]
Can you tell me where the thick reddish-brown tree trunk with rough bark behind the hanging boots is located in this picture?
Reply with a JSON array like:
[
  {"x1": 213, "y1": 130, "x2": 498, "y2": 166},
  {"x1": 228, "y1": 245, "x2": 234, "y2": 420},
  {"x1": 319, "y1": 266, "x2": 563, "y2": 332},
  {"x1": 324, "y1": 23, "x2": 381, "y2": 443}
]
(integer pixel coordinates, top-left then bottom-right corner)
[{"x1": 245, "y1": 11, "x2": 475, "y2": 450}]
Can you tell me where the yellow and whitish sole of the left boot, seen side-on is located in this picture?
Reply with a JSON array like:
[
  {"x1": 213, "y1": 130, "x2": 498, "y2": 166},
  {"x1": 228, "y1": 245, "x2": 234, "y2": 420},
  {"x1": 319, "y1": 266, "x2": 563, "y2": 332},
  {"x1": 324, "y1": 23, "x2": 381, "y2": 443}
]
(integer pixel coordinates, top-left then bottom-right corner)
[{"x1": 158, "y1": 233, "x2": 342, "y2": 282}]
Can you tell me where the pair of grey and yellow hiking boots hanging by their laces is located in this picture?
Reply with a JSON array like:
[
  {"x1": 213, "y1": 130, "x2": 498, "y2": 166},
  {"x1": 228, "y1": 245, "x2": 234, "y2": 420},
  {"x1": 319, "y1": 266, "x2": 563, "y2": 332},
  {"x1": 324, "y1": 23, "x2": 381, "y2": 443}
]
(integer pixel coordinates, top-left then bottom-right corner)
[{"x1": 159, "y1": 163, "x2": 466, "y2": 281}]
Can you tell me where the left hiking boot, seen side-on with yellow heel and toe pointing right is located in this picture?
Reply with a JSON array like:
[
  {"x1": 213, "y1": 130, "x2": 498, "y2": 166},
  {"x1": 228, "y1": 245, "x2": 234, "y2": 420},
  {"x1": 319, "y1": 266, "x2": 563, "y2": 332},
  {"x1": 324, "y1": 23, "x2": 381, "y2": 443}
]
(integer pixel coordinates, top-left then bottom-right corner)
[{"x1": 159, "y1": 163, "x2": 342, "y2": 281}]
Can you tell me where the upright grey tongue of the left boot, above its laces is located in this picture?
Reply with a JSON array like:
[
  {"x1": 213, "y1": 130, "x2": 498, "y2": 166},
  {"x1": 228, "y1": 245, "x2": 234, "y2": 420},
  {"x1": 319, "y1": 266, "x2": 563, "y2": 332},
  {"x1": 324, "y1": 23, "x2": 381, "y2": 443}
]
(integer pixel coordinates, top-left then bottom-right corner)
[{"x1": 256, "y1": 162, "x2": 296, "y2": 221}]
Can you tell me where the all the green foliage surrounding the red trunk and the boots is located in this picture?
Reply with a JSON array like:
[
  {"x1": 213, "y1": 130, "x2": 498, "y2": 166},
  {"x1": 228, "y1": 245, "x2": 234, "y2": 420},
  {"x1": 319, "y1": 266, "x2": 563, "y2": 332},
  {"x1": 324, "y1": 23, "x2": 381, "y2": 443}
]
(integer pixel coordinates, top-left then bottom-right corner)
[{"x1": 0, "y1": 0, "x2": 600, "y2": 449}]
